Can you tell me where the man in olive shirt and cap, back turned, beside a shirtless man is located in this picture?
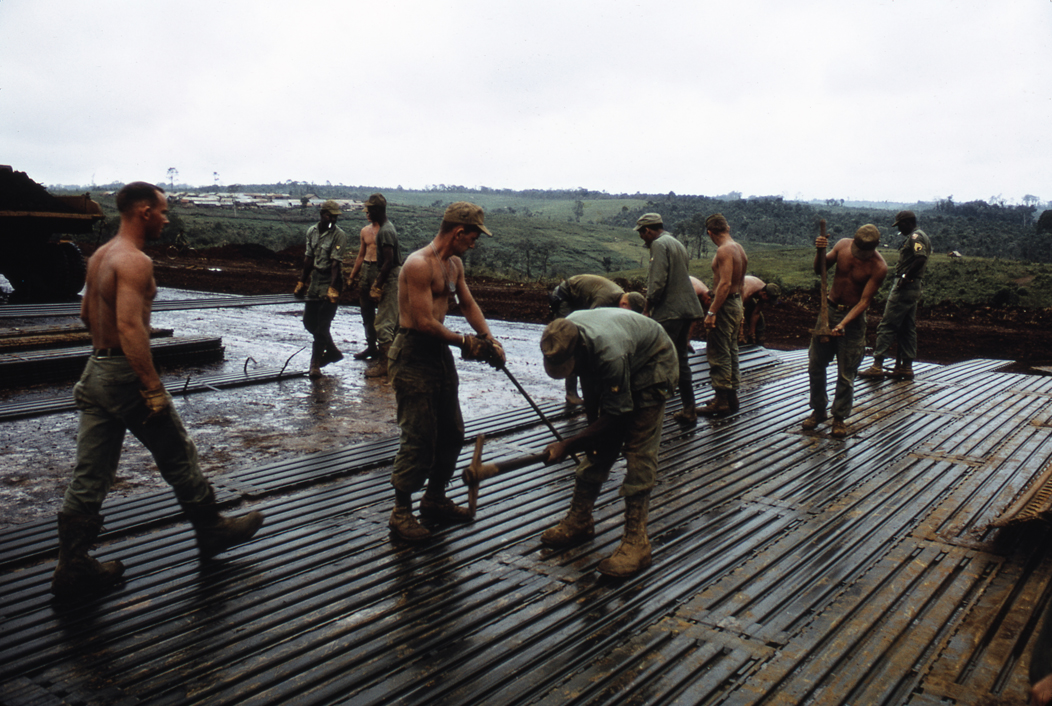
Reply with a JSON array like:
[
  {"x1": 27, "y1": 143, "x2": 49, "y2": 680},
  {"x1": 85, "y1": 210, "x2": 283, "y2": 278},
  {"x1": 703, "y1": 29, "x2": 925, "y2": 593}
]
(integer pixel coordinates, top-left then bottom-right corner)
[{"x1": 635, "y1": 214, "x2": 705, "y2": 426}]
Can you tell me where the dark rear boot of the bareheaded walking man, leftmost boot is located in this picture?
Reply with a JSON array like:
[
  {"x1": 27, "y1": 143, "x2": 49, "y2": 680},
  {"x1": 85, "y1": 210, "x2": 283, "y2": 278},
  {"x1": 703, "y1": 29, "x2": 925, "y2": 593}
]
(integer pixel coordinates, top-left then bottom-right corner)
[{"x1": 52, "y1": 512, "x2": 124, "y2": 601}]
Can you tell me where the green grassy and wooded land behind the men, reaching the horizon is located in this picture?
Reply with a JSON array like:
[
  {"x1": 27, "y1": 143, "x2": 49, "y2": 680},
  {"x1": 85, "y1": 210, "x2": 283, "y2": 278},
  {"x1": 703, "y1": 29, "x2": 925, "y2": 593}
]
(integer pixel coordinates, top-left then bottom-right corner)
[{"x1": 76, "y1": 189, "x2": 1052, "y2": 308}]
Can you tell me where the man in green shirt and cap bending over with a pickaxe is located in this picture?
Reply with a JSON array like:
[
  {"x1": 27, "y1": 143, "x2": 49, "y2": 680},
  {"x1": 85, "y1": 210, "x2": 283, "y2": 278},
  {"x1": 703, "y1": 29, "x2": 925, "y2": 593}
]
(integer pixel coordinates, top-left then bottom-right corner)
[{"x1": 541, "y1": 307, "x2": 680, "y2": 578}]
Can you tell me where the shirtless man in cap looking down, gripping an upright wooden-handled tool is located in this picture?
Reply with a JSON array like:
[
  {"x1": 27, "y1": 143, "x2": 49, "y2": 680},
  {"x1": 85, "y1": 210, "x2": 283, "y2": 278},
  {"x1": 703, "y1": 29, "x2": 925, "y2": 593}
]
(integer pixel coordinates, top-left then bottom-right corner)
[{"x1": 803, "y1": 224, "x2": 888, "y2": 439}]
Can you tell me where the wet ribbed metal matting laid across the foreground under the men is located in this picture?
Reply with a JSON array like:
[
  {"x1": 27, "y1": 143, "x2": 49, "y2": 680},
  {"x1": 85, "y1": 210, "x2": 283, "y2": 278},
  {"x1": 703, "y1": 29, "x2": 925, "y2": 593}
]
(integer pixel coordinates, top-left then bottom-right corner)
[{"x1": 0, "y1": 347, "x2": 1052, "y2": 706}]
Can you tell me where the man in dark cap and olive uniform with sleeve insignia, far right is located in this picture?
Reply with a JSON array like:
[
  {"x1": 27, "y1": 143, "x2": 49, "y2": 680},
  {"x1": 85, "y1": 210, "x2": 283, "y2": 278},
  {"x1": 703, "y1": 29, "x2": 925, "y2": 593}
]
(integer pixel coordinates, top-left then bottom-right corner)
[{"x1": 858, "y1": 210, "x2": 931, "y2": 380}]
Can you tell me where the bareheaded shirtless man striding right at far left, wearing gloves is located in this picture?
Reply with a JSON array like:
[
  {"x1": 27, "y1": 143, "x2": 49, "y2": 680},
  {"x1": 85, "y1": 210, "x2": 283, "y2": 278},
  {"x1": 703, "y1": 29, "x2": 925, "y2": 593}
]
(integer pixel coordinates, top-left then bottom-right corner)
[{"x1": 52, "y1": 182, "x2": 263, "y2": 600}]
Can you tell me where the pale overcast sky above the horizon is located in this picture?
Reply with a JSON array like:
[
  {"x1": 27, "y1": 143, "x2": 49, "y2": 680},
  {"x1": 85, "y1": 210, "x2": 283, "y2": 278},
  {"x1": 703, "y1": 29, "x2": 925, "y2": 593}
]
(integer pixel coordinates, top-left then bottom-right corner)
[{"x1": 0, "y1": 0, "x2": 1052, "y2": 203}]
